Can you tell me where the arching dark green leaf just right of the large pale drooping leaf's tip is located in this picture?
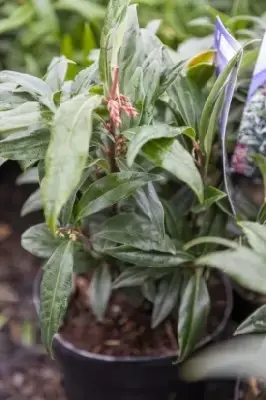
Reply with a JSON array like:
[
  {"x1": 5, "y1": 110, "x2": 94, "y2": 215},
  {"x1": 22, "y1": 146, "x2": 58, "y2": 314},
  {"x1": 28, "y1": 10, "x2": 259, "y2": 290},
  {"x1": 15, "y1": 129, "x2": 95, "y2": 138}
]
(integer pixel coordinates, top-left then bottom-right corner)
[{"x1": 78, "y1": 172, "x2": 160, "y2": 219}]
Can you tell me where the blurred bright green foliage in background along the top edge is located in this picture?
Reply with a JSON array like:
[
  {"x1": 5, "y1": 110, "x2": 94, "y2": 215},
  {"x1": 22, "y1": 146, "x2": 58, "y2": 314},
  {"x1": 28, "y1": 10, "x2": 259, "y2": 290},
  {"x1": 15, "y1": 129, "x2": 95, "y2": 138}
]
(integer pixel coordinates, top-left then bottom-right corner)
[{"x1": 0, "y1": 0, "x2": 266, "y2": 76}]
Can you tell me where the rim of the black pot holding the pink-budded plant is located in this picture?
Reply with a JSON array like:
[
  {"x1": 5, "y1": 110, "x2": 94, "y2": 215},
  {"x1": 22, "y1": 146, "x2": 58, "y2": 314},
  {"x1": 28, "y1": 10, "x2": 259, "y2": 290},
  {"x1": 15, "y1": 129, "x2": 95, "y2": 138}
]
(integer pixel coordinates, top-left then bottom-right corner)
[{"x1": 33, "y1": 269, "x2": 233, "y2": 363}]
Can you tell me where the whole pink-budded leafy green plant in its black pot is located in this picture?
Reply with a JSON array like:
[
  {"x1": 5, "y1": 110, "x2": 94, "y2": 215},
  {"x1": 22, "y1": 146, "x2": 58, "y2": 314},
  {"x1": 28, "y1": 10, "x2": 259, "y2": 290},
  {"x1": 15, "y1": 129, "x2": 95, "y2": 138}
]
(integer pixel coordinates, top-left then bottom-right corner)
[{"x1": 0, "y1": 0, "x2": 265, "y2": 399}]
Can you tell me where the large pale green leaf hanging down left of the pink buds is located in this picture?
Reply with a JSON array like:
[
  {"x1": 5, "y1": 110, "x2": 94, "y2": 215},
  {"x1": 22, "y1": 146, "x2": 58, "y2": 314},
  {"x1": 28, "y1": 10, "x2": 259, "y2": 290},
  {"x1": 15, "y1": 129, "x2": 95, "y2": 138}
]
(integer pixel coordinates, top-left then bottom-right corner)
[{"x1": 42, "y1": 94, "x2": 102, "y2": 231}]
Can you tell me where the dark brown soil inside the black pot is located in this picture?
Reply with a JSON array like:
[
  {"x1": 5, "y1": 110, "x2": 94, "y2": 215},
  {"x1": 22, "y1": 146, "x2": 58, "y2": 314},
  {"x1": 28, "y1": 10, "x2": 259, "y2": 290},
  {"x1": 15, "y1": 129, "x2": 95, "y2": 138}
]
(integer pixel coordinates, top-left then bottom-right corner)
[{"x1": 61, "y1": 276, "x2": 229, "y2": 356}]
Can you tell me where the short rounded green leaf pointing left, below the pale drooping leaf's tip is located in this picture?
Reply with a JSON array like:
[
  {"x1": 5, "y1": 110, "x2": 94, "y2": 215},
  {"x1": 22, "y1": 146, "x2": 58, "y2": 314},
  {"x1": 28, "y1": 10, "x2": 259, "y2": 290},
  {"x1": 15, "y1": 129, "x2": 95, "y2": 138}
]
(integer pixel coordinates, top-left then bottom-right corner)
[{"x1": 21, "y1": 224, "x2": 62, "y2": 258}]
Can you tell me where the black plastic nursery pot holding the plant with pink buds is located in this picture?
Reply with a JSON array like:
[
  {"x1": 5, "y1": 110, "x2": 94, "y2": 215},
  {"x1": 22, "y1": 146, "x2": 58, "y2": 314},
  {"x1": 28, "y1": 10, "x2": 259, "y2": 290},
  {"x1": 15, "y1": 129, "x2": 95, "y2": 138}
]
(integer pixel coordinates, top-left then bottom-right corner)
[{"x1": 34, "y1": 274, "x2": 233, "y2": 400}]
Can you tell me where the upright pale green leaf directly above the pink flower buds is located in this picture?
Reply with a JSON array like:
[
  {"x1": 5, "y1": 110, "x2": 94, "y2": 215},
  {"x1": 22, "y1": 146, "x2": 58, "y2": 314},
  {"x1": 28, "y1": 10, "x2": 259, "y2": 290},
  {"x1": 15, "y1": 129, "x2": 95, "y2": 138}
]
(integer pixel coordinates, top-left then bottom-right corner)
[{"x1": 99, "y1": 0, "x2": 129, "y2": 89}]
